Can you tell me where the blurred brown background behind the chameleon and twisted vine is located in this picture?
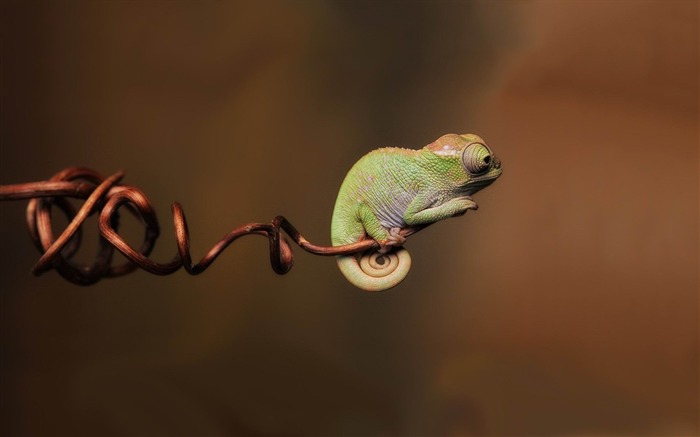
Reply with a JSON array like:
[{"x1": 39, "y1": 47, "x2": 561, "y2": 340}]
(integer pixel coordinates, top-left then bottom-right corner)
[{"x1": 0, "y1": 1, "x2": 699, "y2": 436}]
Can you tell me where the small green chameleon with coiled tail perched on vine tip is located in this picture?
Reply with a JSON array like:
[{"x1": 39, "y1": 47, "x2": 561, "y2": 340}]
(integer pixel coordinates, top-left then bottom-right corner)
[{"x1": 331, "y1": 134, "x2": 501, "y2": 291}]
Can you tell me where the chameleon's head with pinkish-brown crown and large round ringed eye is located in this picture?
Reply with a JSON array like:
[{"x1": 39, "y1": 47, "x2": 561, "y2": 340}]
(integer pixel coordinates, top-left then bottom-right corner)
[{"x1": 425, "y1": 134, "x2": 503, "y2": 195}]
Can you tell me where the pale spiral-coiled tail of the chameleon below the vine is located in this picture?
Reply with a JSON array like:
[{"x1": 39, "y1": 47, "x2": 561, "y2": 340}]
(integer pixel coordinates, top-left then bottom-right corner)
[{"x1": 338, "y1": 247, "x2": 411, "y2": 291}]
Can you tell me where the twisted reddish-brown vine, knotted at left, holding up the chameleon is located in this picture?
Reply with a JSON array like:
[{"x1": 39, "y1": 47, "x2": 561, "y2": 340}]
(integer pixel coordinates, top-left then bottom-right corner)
[{"x1": 0, "y1": 167, "x2": 386, "y2": 285}]
